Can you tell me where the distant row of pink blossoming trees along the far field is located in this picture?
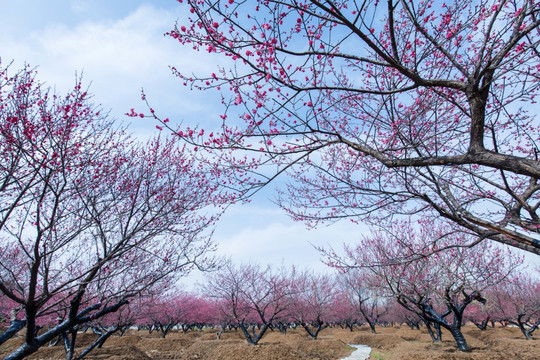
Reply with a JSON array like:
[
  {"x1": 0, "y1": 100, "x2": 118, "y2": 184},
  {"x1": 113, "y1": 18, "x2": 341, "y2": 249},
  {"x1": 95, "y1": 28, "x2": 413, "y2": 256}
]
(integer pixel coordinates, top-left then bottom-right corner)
[{"x1": 0, "y1": 256, "x2": 540, "y2": 359}]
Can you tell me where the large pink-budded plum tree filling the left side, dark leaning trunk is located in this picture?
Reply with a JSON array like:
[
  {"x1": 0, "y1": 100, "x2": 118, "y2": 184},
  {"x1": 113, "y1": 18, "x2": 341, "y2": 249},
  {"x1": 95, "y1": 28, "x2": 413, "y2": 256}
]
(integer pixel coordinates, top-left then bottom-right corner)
[{"x1": 0, "y1": 63, "x2": 233, "y2": 359}]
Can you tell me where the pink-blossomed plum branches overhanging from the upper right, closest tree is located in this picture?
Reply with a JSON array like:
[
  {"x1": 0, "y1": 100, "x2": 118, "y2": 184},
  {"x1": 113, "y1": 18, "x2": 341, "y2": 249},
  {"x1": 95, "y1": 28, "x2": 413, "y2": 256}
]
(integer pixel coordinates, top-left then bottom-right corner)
[{"x1": 154, "y1": 0, "x2": 540, "y2": 254}]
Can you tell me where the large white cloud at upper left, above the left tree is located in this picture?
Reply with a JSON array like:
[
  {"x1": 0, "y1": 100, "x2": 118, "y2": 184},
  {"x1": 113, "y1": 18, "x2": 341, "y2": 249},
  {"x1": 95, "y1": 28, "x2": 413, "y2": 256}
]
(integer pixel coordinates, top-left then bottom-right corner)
[{"x1": 0, "y1": 1, "x2": 221, "y2": 136}]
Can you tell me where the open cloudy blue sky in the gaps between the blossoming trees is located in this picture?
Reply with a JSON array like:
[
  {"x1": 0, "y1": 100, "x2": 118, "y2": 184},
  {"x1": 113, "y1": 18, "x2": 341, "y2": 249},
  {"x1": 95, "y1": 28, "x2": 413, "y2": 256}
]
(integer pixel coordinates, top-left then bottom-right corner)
[{"x1": 0, "y1": 0, "x2": 365, "y2": 284}]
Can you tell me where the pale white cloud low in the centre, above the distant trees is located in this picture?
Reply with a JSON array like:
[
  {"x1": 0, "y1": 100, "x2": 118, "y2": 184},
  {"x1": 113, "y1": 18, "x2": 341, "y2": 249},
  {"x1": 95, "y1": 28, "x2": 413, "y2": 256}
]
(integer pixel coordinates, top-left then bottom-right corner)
[{"x1": 182, "y1": 201, "x2": 368, "y2": 288}]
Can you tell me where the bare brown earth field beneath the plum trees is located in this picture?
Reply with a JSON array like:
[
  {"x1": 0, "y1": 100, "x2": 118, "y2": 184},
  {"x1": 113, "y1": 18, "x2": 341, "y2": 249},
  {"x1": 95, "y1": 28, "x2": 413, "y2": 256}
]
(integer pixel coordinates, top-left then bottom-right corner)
[{"x1": 0, "y1": 325, "x2": 540, "y2": 360}]
